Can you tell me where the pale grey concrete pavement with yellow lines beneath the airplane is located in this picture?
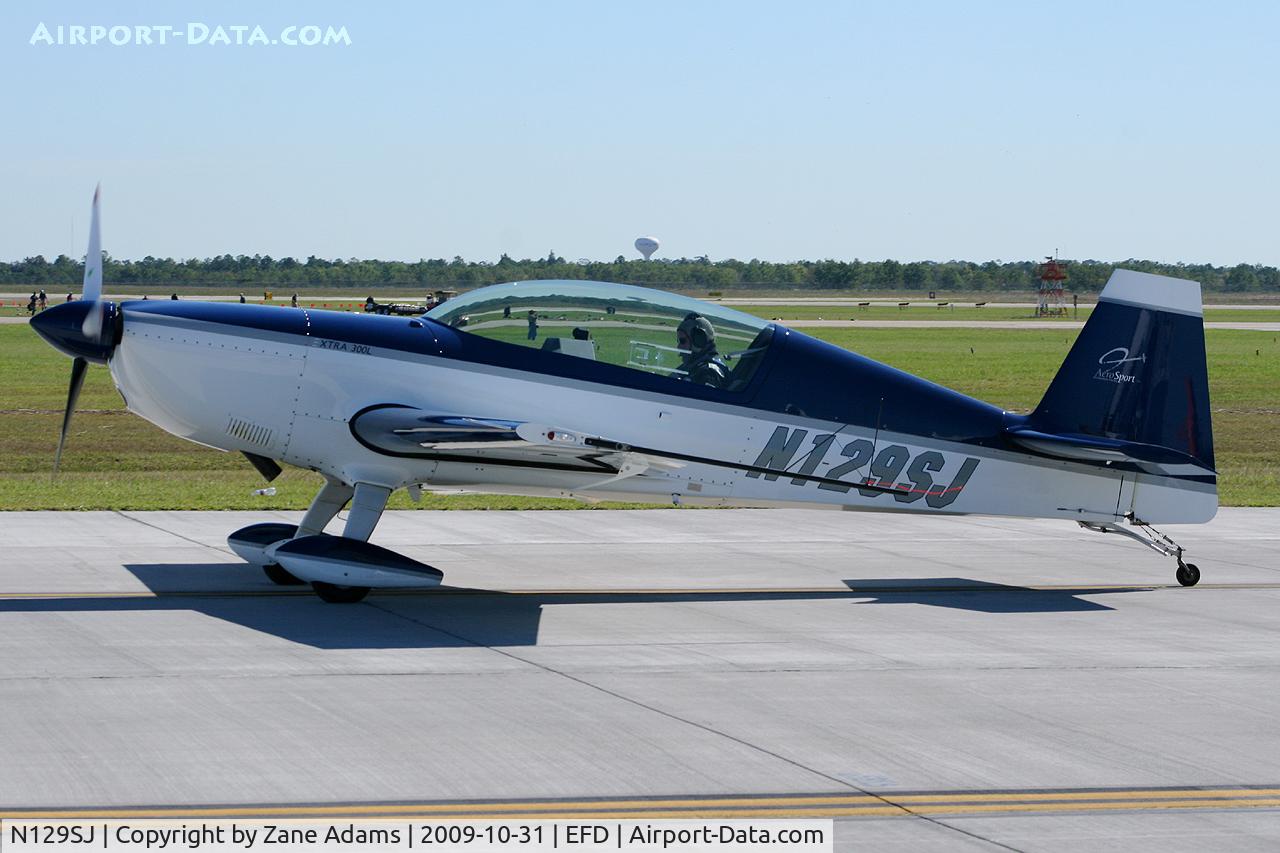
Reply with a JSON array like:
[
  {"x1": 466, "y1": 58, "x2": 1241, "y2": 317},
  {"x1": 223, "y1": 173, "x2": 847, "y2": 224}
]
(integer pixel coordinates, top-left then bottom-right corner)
[{"x1": 0, "y1": 508, "x2": 1280, "y2": 850}]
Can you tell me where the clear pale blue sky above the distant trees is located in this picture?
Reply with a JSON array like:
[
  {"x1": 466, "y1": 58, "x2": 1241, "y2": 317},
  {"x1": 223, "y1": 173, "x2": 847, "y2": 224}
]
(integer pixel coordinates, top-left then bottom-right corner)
[{"x1": 0, "y1": 0, "x2": 1280, "y2": 264}]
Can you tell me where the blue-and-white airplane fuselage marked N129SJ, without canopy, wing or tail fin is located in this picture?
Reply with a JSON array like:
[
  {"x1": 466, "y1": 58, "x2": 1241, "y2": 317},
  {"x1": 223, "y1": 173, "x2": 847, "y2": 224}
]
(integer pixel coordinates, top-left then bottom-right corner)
[{"x1": 109, "y1": 292, "x2": 1216, "y2": 521}]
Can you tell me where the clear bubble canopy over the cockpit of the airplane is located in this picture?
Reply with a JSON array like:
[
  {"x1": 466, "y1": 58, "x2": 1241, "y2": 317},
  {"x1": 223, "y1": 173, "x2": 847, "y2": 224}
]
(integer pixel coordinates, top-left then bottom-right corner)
[{"x1": 426, "y1": 280, "x2": 773, "y2": 391}]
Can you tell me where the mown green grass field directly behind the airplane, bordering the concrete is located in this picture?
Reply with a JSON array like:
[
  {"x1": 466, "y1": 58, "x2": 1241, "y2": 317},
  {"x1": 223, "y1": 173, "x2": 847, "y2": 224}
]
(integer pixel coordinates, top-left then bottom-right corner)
[{"x1": 0, "y1": 317, "x2": 1280, "y2": 510}]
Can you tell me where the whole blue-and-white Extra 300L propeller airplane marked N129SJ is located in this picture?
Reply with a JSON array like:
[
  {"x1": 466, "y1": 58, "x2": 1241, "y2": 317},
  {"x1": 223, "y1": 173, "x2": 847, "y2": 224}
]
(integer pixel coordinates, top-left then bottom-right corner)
[{"x1": 32, "y1": 193, "x2": 1217, "y2": 602}]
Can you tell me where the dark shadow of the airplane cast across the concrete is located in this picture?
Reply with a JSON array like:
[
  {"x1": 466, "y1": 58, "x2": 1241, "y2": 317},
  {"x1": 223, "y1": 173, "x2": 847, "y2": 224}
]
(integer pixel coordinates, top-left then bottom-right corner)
[{"x1": 0, "y1": 564, "x2": 1147, "y2": 649}]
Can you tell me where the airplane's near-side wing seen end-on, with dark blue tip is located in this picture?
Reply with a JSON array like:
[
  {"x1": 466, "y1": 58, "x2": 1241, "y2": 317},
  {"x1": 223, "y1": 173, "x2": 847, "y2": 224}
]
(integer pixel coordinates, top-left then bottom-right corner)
[{"x1": 351, "y1": 403, "x2": 904, "y2": 494}]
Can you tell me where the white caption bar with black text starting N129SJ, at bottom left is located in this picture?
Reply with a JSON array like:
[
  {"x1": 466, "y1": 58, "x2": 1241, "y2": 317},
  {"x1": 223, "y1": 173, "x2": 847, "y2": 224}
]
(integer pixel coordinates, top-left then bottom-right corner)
[{"x1": 0, "y1": 820, "x2": 833, "y2": 853}]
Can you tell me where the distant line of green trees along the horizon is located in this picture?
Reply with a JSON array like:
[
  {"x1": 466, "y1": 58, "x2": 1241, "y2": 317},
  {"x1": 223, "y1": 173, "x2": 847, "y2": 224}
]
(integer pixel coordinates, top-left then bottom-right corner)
[{"x1": 0, "y1": 252, "x2": 1280, "y2": 293}]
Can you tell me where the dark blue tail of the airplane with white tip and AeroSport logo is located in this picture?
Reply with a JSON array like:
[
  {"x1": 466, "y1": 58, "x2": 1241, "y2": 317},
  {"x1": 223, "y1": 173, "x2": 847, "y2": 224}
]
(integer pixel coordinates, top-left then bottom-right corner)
[{"x1": 1009, "y1": 269, "x2": 1217, "y2": 521}]
